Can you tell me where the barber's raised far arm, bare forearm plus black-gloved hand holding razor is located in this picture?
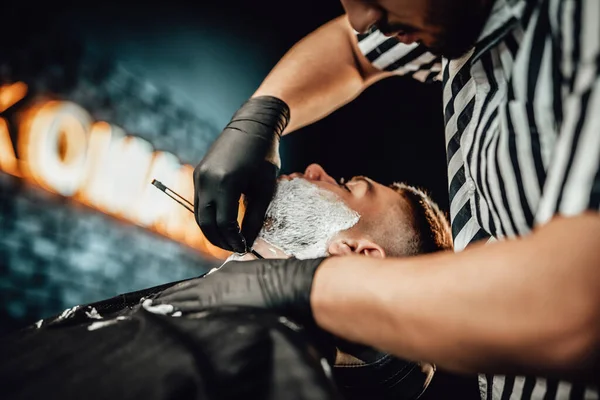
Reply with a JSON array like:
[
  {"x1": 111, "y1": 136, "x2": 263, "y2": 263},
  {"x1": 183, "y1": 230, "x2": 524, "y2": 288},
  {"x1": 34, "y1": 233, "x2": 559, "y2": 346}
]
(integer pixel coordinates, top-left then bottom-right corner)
[{"x1": 194, "y1": 16, "x2": 391, "y2": 252}]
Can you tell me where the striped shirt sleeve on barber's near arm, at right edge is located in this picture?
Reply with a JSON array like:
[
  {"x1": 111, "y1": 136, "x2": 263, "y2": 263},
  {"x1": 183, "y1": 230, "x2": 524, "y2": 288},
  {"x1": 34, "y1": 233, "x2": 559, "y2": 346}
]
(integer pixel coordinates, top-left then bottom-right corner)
[{"x1": 536, "y1": 0, "x2": 600, "y2": 223}]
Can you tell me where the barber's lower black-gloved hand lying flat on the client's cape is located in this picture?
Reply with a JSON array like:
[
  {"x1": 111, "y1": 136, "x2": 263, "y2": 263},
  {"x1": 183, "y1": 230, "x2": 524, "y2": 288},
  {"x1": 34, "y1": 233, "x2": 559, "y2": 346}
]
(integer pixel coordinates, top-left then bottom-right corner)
[{"x1": 152, "y1": 258, "x2": 324, "y2": 324}]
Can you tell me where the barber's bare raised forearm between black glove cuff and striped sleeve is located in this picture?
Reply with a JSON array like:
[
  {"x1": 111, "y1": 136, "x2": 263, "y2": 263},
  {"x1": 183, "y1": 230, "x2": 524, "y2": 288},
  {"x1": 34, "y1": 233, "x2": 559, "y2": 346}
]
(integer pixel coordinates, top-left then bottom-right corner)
[{"x1": 254, "y1": 16, "x2": 390, "y2": 134}]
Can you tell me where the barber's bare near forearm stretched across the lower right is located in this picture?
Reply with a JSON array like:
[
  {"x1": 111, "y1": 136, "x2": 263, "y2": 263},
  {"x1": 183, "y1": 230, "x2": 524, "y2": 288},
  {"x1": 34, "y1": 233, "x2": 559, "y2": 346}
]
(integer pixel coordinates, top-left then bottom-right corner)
[{"x1": 311, "y1": 215, "x2": 600, "y2": 375}]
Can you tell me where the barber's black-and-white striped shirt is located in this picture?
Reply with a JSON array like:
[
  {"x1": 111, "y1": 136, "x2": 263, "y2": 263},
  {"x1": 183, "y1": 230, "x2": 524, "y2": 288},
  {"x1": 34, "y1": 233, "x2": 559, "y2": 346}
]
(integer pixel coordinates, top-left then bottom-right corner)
[{"x1": 358, "y1": 0, "x2": 600, "y2": 400}]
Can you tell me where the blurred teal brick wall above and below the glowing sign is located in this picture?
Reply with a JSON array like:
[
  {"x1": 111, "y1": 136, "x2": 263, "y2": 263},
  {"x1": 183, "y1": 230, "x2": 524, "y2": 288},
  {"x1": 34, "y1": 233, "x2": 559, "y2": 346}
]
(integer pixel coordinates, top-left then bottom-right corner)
[{"x1": 0, "y1": 27, "x2": 223, "y2": 332}]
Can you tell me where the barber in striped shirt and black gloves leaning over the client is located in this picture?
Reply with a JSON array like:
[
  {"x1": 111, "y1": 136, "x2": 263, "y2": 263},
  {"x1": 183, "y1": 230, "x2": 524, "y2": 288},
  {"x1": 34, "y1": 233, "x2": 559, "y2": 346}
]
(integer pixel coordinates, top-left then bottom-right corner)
[{"x1": 185, "y1": 0, "x2": 600, "y2": 400}]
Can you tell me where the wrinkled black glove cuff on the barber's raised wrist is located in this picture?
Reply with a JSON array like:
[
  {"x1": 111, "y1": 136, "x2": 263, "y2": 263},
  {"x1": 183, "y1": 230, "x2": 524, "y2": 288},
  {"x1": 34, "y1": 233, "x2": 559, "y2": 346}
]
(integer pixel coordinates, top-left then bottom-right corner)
[{"x1": 229, "y1": 96, "x2": 290, "y2": 139}]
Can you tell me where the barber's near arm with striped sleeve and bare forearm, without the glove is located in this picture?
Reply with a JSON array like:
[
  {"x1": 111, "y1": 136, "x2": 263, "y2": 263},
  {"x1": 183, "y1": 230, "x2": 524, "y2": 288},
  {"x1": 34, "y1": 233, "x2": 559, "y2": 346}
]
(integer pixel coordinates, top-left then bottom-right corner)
[{"x1": 311, "y1": 0, "x2": 600, "y2": 383}]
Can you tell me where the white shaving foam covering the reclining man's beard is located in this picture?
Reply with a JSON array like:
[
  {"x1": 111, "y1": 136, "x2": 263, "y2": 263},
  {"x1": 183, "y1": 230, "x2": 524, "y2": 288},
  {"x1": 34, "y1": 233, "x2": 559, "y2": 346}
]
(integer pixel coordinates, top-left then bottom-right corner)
[{"x1": 258, "y1": 178, "x2": 360, "y2": 259}]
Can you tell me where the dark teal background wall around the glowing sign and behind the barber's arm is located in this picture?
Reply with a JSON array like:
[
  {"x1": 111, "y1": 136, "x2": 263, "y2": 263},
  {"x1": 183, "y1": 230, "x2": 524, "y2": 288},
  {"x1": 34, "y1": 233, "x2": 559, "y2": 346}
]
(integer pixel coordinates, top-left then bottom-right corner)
[{"x1": 0, "y1": 0, "x2": 476, "y2": 399}]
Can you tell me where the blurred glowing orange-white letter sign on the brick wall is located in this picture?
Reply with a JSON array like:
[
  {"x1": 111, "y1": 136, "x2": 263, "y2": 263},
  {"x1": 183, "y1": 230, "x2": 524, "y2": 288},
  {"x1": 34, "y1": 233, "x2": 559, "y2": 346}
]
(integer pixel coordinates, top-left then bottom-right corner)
[{"x1": 0, "y1": 82, "x2": 234, "y2": 259}]
